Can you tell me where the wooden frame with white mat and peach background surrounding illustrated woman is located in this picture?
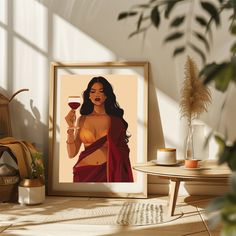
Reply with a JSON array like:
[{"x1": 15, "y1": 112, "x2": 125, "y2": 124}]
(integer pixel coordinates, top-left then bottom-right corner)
[{"x1": 48, "y1": 61, "x2": 149, "y2": 198}]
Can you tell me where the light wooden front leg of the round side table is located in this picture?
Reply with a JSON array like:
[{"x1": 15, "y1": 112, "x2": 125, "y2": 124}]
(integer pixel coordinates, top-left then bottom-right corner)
[{"x1": 168, "y1": 179, "x2": 180, "y2": 216}]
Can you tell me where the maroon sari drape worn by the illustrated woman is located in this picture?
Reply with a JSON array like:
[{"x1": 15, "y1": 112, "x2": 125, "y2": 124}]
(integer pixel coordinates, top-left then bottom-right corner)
[{"x1": 73, "y1": 116, "x2": 133, "y2": 182}]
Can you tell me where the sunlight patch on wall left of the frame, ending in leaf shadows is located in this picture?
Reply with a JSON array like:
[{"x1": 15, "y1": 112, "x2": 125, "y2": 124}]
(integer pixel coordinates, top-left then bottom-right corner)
[{"x1": 12, "y1": 38, "x2": 49, "y2": 122}]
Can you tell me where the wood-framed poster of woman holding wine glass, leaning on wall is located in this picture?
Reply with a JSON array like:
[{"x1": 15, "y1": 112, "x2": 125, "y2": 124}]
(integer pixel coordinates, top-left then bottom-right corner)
[{"x1": 48, "y1": 62, "x2": 148, "y2": 198}]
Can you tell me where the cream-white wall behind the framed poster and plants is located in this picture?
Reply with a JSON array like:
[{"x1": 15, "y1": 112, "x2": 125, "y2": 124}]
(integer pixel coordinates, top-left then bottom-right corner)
[{"x1": 0, "y1": 0, "x2": 236, "y2": 195}]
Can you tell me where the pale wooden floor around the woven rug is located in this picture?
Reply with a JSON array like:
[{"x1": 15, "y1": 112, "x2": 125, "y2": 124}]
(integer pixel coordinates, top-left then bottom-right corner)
[{"x1": 0, "y1": 196, "x2": 221, "y2": 236}]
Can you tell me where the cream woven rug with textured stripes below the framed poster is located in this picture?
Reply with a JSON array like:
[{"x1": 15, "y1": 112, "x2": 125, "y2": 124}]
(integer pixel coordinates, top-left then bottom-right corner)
[{"x1": 0, "y1": 198, "x2": 181, "y2": 226}]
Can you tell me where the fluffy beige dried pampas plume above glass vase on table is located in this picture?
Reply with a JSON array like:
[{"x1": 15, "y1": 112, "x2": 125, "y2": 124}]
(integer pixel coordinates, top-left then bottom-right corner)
[{"x1": 180, "y1": 56, "x2": 211, "y2": 125}]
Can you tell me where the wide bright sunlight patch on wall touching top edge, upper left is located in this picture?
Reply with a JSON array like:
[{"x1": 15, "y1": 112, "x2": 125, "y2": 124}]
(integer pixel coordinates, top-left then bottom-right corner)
[{"x1": 13, "y1": 0, "x2": 48, "y2": 52}]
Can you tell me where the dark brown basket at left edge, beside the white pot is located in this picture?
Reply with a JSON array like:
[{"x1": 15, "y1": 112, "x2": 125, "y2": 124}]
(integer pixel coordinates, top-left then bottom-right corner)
[{"x1": 0, "y1": 176, "x2": 20, "y2": 202}]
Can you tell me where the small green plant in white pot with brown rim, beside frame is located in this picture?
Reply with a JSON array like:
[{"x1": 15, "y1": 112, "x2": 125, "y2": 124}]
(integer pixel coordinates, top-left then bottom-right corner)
[{"x1": 18, "y1": 152, "x2": 45, "y2": 205}]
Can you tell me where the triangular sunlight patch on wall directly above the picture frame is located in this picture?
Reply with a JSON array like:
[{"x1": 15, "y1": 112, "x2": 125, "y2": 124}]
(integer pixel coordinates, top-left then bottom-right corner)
[{"x1": 52, "y1": 15, "x2": 115, "y2": 61}]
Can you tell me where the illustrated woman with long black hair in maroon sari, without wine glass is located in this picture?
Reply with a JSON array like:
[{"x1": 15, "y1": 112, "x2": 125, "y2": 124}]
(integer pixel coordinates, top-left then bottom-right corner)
[{"x1": 65, "y1": 76, "x2": 133, "y2": 182}]
